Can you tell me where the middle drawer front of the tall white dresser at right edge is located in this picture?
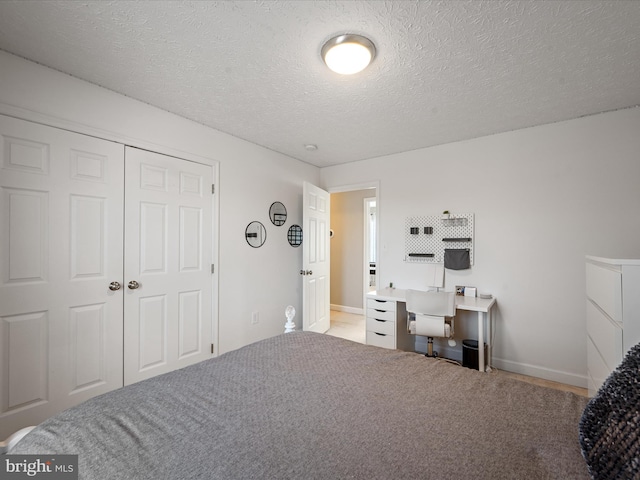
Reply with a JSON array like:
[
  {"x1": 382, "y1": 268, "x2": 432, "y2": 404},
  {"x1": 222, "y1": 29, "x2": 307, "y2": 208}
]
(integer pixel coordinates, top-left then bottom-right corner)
[{"x1": 587, "y1": 300, "x2": 623, "y2": 370}]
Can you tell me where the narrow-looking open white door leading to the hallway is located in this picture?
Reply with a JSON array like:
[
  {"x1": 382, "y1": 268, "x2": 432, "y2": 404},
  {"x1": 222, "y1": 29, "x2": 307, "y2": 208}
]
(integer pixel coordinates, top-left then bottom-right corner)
[{"x1": 300, "y1": 182, "x2": 331, "y2": 333}]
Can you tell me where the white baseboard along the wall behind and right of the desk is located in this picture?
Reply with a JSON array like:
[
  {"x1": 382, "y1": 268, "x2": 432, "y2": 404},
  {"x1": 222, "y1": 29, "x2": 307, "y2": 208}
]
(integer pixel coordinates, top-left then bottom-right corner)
[{"x1": 415, "y1": 336, "x2": 588, "y2": 388}]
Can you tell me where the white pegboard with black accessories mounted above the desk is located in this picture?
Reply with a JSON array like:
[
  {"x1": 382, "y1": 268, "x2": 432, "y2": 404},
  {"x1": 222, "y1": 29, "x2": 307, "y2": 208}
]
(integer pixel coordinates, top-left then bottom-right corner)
[{"x1": 404, "y1": 213, "x2": 474, "y2": 265}]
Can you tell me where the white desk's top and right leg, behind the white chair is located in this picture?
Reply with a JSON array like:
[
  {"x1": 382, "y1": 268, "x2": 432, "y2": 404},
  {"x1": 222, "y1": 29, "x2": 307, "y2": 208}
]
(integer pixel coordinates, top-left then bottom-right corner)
[{"x1": 367, "y1": 288, "x2": 496, "y2": 372}]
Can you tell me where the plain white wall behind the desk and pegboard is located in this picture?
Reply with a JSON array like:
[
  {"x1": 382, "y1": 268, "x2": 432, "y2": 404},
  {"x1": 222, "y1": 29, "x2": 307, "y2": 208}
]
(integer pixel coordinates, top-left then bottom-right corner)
[{"x1": 321, "y1": 108, "x2": 640, "y2": 386}]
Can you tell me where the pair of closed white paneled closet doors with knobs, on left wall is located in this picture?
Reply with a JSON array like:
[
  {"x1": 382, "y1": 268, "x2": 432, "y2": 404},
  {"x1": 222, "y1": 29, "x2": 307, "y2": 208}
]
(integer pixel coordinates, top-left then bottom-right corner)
[{"x1": 0, "y1": 115, "x2": 213, "y2": 440}]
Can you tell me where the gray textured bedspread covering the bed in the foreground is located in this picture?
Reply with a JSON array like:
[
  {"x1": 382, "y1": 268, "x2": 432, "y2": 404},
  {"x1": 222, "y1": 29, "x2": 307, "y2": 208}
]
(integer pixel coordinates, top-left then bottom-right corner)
[{"x1": 11, "y1": 332, "x2": 589, "y2": 480}]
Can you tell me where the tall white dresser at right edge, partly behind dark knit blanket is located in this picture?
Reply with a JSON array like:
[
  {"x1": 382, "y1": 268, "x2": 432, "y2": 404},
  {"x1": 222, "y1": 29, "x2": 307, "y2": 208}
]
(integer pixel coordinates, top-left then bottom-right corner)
[{"x1": 586, "y1": 256, "x2": 640, "y2": 396}]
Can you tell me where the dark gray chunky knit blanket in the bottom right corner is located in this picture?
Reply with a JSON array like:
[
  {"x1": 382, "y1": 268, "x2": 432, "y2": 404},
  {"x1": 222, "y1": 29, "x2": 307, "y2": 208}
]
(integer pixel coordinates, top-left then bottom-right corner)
[{"x1": 579, "y1": 344, "x2": 640, "y2": 480}]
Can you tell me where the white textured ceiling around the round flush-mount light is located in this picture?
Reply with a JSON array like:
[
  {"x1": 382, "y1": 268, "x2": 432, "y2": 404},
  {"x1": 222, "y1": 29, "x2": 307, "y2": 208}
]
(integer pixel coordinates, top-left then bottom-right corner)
[{"x1": 0, "y1": 0, "x2": 640, "y2": 166}]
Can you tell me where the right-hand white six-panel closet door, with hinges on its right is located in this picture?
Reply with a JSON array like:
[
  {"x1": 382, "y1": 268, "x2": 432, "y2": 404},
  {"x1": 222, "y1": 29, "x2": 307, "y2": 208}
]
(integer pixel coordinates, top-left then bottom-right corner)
[{"x1": 124, "y1": 147, "x2": 213, "y2": 385}]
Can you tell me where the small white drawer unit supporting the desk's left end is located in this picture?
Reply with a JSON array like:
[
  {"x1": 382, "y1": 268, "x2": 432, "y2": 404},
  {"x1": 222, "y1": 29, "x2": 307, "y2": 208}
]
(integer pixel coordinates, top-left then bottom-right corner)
[{"x1": 367, "y1": 290, "x2": 415, "y2": 351}]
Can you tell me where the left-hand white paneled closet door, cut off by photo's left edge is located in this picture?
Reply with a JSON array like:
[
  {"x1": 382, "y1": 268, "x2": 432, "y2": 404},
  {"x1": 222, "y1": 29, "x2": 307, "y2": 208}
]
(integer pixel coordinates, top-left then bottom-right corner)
[{"x1": 0, "y1": 116, "x2": 124, "y2": 439}]
